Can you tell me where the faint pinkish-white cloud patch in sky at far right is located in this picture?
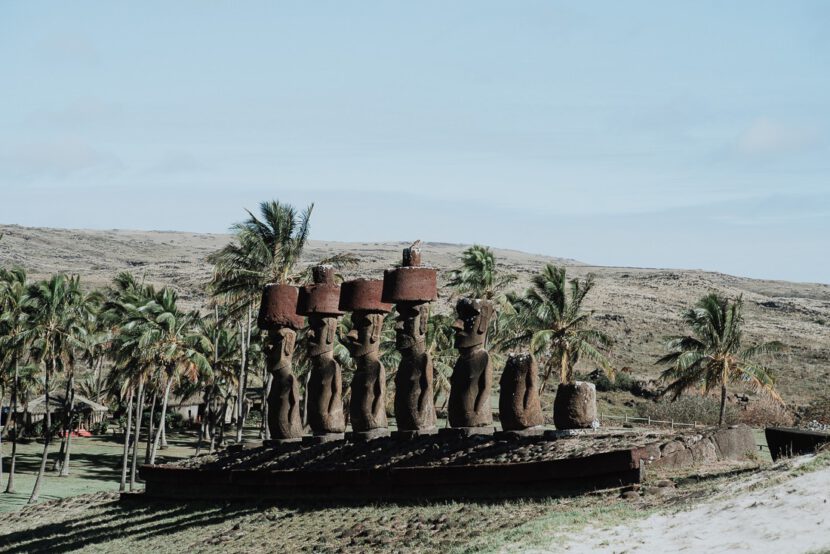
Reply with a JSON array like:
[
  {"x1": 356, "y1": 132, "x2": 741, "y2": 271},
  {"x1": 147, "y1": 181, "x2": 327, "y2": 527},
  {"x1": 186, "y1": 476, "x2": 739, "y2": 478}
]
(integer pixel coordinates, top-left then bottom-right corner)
[{"x1": 737, "y1": 118, "x2": 818, "y2": 158}]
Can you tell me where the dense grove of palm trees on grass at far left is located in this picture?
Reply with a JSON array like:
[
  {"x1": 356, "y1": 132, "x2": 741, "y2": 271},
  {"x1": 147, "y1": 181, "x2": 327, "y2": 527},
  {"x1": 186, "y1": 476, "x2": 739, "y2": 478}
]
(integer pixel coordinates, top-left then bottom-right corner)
[{"x1": 0, "y1": 268, "x2": 218, "y2": 502}]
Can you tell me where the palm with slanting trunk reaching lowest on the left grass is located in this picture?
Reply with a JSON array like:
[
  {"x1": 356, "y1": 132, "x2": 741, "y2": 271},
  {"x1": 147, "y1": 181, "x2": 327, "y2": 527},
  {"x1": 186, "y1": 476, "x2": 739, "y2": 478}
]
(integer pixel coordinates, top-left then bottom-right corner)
[{"x1": 26, "y1": 274, "x2": 85, "y2": 504}]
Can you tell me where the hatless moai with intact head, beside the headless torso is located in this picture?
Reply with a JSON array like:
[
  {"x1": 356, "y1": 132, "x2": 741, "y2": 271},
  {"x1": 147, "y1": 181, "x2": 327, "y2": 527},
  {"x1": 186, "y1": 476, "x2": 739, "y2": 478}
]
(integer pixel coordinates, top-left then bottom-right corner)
[{"x1": 447, "y1": 298, "x2": 494, "y2": 434}]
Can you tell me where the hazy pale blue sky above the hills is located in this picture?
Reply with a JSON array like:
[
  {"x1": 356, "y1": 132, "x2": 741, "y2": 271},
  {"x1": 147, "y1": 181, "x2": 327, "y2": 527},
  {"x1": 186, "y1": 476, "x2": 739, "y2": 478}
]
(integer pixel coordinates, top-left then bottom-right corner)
[{"x1": 0, "y1": 0, "x2": 830, "y2": 283}]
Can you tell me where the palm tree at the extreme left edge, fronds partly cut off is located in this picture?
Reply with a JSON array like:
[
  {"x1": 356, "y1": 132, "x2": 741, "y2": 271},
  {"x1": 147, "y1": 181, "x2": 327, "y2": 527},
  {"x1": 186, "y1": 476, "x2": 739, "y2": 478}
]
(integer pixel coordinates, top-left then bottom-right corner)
[{"x1": 0, "y1": 268, "x2": 30, "y2": 493}]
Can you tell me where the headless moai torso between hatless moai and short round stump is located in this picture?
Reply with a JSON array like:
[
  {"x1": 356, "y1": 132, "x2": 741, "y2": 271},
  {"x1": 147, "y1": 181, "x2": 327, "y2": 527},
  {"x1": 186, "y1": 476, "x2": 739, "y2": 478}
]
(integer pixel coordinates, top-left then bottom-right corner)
[{"x1": 499, "y1": 354, "x2": 545, "y2": 434}]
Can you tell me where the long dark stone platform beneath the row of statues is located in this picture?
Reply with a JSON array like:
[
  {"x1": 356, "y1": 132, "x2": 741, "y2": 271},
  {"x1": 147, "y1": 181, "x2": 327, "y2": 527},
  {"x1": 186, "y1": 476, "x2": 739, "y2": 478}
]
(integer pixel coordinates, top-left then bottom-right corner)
[{"x1": 139, "y1": 426, "x2": 756, "y2": 501}]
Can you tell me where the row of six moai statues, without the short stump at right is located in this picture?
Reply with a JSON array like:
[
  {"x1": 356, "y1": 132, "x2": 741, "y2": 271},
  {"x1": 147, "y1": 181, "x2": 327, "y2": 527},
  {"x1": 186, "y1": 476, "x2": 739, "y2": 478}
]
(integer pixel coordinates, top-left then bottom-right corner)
[{"x1": 258, "y1": 247, "x2": 544, "y2": 442}]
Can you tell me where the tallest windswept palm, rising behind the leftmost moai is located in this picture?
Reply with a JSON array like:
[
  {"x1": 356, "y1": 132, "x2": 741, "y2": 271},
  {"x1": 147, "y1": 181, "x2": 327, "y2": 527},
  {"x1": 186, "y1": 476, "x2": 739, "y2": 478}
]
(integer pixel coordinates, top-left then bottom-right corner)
[{"x1": 208, "y1": 200, "x2": 314, "y2": 442}]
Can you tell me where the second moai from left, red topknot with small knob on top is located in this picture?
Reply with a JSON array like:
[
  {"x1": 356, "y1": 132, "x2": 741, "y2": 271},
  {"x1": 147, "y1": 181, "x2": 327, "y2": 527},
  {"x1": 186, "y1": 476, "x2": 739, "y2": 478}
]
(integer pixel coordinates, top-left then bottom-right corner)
[{"x1": 297, "y1": 265, "x2": 346, "y2": 442}]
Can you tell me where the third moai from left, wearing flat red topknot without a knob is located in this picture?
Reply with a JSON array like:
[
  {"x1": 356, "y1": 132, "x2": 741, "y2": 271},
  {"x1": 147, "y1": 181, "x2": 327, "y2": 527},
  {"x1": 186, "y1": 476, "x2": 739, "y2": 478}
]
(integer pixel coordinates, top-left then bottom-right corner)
[{"x1": 340, "y1": 279, "x2": 392, "y2": 440}]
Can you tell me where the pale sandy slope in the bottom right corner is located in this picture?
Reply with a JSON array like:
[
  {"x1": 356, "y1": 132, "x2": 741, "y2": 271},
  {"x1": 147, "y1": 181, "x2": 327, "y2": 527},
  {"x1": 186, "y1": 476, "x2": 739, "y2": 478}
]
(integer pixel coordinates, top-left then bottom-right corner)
[{"x1": 541, "y1": 458, "x2": 830, "y2": 554}]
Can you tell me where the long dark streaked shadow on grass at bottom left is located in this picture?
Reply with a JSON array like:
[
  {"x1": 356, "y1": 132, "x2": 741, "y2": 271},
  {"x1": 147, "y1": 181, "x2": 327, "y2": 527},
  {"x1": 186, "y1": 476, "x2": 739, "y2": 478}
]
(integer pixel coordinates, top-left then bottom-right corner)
[{"x1": 0, "y1": 498, "x2": 256, "y2": 552}]
